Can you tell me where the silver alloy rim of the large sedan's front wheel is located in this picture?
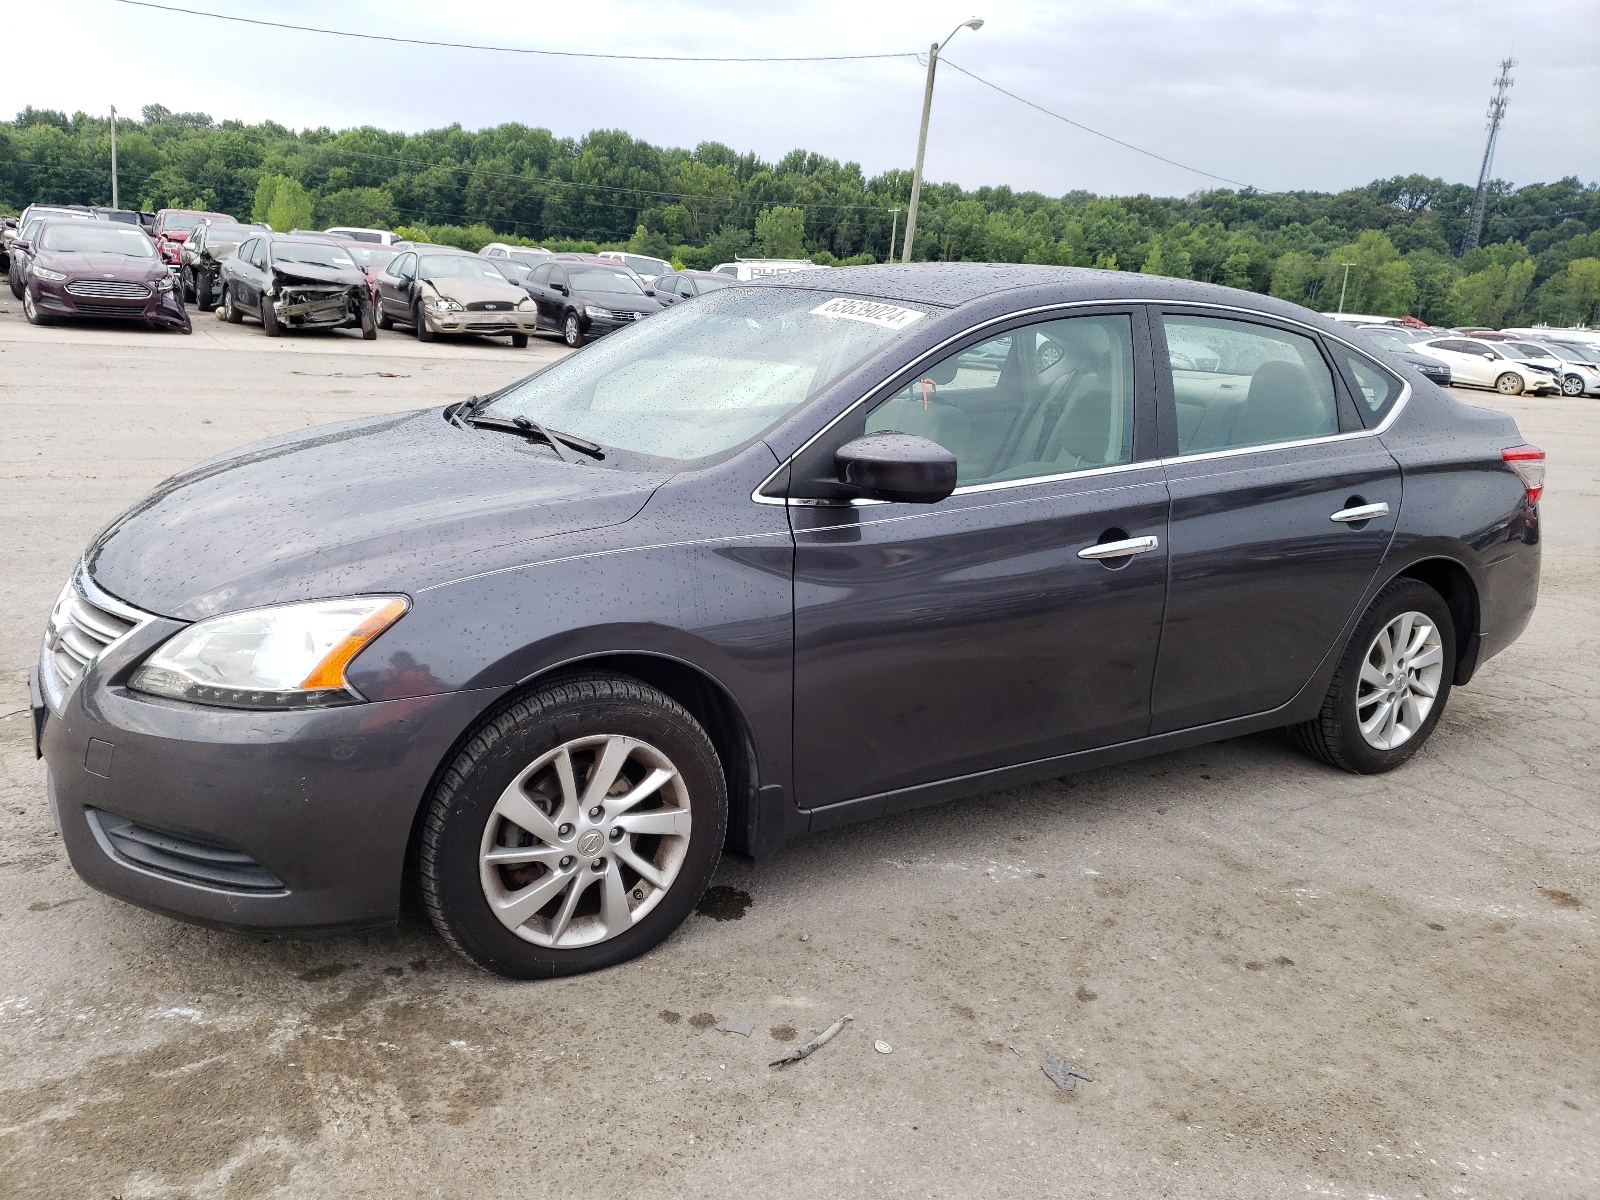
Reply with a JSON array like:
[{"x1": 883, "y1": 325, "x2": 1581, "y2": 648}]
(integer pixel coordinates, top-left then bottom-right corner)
[{"x1": 478, "y1": 734, "x2": 691, "y2": 950}]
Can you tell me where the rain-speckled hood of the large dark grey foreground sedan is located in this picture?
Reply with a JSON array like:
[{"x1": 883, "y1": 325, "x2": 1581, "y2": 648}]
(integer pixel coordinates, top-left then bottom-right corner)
[{"x1": 85, "y1": 408, "x2": 667, "y2": 621}]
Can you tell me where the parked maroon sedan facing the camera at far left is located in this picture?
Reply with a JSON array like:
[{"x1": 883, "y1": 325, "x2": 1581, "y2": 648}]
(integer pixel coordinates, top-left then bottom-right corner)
[{"x1": 22, "y1": 221, "x2": 189, "y2": 333}]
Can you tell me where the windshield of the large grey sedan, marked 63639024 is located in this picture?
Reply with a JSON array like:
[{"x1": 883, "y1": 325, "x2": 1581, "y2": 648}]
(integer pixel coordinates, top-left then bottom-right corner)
[{"x1": 485, "y1": 288, "x2": 926, "y2": 469}]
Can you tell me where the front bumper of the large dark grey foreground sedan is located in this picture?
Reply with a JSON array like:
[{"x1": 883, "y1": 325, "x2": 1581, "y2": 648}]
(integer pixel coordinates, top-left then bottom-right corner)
[{"x1": 40, "y1": 618, "x2": 499, "y2": 936}]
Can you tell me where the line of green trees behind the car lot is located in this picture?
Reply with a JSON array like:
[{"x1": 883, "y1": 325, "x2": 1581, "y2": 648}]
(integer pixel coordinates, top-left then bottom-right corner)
[{"x1": 0, "y1": 104, "x2": 1600, "y2": 326}]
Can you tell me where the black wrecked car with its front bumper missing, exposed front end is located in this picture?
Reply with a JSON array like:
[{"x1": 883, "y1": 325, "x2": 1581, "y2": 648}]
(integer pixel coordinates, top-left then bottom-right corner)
[{"x1": 221, "y1": 234, "x2": 378, "y2": 341}]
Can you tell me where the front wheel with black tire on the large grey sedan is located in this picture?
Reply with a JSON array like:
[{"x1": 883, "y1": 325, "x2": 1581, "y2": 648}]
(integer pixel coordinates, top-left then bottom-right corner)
[{"x1": 418, "y1": 672, "x2": 728, "y2": 979}]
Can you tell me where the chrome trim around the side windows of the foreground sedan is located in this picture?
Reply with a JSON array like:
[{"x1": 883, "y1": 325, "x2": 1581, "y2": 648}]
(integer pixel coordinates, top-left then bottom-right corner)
[{"x1": 750, "y1": 298, "x2": 1413, "y2": 509}]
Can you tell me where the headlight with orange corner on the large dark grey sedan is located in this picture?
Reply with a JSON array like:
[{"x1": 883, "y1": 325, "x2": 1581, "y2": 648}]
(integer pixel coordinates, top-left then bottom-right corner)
[{"x1": 128, "y1": 595, "x2": 410, "y2": 709}]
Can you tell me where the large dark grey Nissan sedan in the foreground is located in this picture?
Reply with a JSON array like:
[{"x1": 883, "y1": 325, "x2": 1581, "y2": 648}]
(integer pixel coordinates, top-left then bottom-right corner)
[{"x1": 34, "y1": 264, "x2": 1544, "y2": 978}]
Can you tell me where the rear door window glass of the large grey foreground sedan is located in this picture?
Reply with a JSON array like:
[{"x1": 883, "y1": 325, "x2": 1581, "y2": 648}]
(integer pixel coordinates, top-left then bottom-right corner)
[{"x1": 1162, "y1": 314, "x2": 1339, "y2": 454}]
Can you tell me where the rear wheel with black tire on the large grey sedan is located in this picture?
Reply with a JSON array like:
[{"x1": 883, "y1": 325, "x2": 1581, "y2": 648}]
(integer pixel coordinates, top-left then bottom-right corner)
[{"x1": 1290, "y1": 579, "x2": 1456, "y2": 774}]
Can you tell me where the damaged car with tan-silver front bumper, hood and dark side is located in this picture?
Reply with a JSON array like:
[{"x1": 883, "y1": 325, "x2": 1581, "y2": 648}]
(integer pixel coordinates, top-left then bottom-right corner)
[{"x1": 378, "y1": 250, "x2": 539, "y2": 349}]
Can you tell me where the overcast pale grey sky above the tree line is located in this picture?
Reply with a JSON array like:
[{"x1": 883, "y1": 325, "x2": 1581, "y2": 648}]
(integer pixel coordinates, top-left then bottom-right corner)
[{"x1": 0, "y1": 0, "x2": 1600, "y2": 195}]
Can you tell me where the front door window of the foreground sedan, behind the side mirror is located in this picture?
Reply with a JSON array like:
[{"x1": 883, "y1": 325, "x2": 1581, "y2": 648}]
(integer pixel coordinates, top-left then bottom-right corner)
[{"x1": 866, "y1": 314, "x2": 1134, "y2": 486}]
